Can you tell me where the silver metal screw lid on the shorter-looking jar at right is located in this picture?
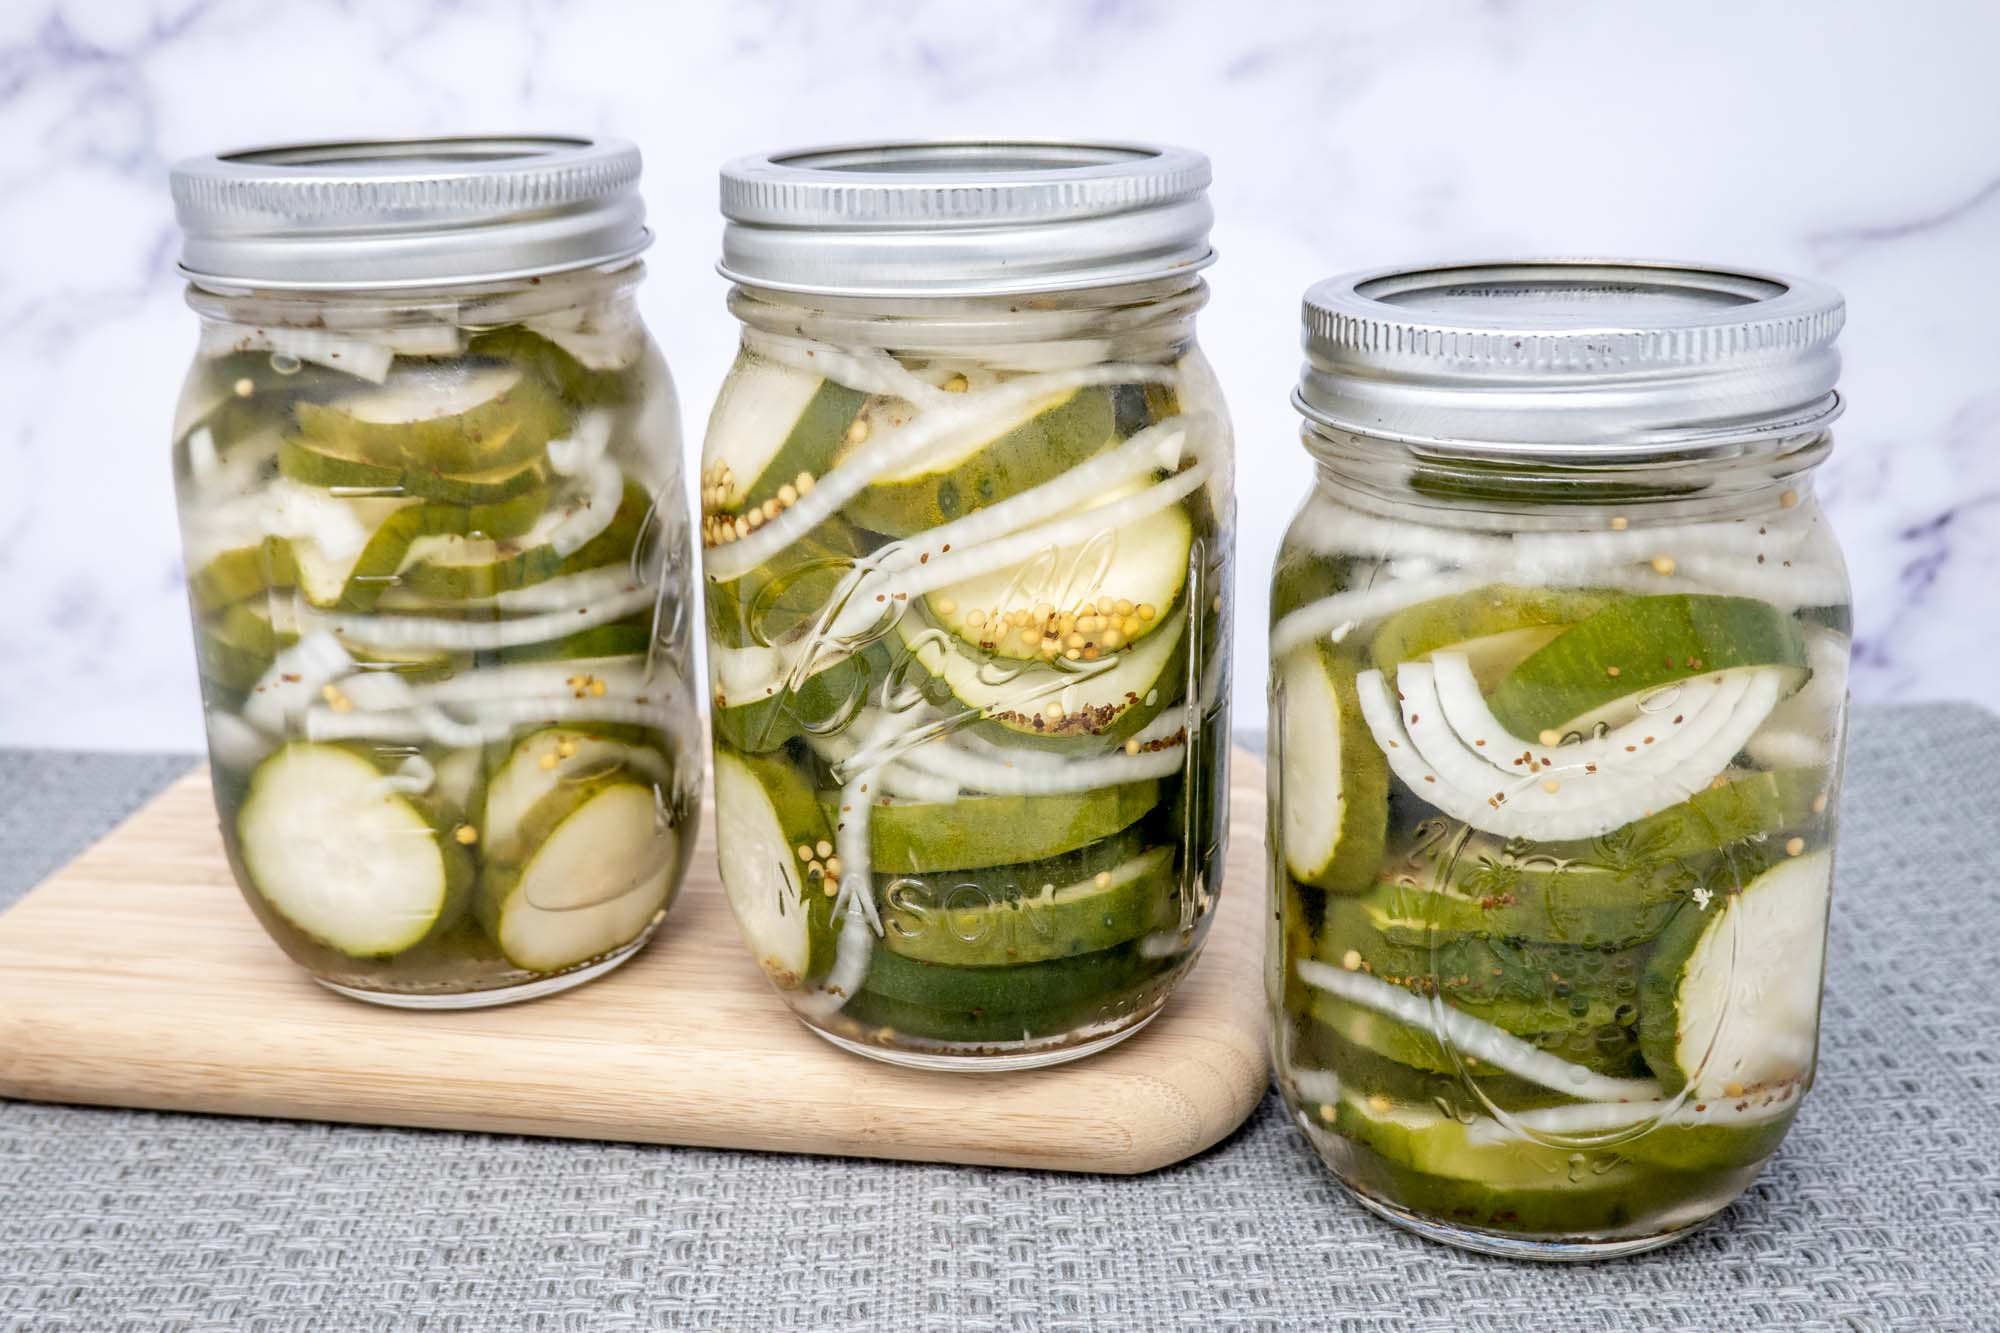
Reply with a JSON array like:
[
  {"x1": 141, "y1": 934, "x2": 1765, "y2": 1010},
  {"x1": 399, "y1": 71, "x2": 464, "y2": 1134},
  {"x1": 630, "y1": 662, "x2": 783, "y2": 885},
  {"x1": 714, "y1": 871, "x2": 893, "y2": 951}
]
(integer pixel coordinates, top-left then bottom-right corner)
[{"x1": 1292, "y1": 258, "x2": 1846, "y2": 462}]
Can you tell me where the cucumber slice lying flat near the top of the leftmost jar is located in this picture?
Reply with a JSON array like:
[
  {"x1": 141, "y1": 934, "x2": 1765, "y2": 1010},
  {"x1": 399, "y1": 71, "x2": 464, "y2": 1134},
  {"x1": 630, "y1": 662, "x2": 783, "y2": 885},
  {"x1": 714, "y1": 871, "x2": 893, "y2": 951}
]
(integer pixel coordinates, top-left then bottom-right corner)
[{"x1": 292, "y1": 360, "x2": 570, "y2": 474}]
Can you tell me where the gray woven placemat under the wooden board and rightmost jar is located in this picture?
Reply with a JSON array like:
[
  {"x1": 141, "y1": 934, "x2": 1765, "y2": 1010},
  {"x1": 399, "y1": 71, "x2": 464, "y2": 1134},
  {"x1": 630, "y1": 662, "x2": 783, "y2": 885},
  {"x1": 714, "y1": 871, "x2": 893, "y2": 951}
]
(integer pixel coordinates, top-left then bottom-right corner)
[{"x1": 0, "y1": 707, "x2": 2000, "y2": 1333}]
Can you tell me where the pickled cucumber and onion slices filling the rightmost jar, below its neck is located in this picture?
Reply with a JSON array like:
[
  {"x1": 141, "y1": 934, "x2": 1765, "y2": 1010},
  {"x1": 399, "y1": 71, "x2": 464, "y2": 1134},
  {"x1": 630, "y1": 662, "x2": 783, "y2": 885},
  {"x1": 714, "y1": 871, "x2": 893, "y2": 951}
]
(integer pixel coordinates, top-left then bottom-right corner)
[{"x1": 1270, "y1": 544, "x2": 1846, "y2": 1235}]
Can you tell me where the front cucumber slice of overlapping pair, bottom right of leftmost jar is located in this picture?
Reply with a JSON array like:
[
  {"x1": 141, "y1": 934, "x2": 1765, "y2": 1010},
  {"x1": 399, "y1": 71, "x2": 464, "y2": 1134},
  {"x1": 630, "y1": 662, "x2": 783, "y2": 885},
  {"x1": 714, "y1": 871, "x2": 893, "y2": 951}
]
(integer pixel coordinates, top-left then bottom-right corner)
[{"x1": 480, "y1": 779, "x2": 680, "y2": 973}]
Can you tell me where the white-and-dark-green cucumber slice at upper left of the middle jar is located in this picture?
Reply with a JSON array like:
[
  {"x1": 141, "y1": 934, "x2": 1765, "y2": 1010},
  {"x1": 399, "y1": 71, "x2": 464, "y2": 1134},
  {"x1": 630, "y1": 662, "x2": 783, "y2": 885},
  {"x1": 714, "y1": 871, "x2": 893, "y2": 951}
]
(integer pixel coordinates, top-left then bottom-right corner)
[{"x1": 702, "y1": 356, "x2": 868, "y2": 514}]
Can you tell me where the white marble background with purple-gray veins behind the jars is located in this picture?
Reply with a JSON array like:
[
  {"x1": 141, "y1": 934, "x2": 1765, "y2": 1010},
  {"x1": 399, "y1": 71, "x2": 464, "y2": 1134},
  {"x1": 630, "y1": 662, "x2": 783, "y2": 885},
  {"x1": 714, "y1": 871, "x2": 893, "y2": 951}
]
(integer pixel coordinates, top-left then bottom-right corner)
[{"x1": 0, "y1": 0, "x2": 2000, "y2": 749}]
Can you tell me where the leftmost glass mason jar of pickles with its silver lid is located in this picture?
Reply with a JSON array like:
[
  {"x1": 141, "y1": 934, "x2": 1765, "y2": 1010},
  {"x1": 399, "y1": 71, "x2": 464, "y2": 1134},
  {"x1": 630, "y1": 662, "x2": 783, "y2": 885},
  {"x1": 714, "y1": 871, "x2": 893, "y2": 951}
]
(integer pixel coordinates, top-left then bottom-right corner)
[{"x1": 174, "y1": 138, "x2": 702, "y2": 1009}]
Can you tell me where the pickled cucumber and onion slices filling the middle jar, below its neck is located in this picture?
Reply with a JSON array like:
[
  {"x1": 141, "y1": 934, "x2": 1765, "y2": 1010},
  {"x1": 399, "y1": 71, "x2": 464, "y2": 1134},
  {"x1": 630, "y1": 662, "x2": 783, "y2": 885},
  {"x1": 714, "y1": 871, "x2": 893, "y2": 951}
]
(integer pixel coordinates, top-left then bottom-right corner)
[{"x1": 700, "y1": 336, "x2": 1228, "y2": 1055}]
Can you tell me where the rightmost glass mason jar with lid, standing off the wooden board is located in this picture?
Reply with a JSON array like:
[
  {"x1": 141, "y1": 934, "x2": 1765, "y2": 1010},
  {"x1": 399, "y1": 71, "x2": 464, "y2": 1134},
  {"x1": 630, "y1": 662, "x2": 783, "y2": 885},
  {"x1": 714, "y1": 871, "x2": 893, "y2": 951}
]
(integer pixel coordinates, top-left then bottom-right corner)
[{"x1": 1268, "y1": 262, "x2": 1850, "y2": 1259}]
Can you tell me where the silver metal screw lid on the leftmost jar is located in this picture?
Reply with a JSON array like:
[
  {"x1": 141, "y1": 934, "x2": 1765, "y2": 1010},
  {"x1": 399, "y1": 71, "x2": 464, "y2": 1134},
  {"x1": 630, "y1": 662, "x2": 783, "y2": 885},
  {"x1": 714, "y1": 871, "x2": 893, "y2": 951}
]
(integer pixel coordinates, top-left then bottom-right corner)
[{"x1": 172, "y1": 134, "x2": 652, "y2": 290}]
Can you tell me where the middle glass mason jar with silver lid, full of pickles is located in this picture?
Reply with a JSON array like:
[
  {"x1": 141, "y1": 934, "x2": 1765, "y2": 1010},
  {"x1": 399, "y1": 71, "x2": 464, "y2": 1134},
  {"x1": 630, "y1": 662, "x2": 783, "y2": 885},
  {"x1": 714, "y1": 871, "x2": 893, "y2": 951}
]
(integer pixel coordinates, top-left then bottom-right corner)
[{"x1": 700, "y1": 144, "x2": 1234, "y2": 1069}]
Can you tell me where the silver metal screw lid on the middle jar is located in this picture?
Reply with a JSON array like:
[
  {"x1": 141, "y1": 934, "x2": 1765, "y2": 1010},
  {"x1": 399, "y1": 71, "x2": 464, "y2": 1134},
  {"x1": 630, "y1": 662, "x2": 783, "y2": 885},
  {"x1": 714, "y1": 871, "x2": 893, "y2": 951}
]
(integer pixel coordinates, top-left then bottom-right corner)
[{"x1": 718, "y1": 140, "x2": 1214, "y2": 296}]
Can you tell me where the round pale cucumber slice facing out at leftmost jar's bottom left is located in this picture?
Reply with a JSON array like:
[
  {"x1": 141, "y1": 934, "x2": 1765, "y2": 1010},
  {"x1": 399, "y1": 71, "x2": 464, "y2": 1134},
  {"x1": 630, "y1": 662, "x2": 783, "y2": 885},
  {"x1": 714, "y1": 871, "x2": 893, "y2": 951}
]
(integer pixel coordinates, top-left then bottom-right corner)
[{"x1": 236, "y1": 743, "x2": 472, "y2": 959}]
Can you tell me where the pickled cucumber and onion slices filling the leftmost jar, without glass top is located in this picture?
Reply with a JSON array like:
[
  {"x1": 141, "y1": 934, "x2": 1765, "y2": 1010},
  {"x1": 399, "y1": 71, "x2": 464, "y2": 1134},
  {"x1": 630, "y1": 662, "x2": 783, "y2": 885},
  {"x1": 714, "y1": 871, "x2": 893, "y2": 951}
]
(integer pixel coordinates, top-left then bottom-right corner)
[{"x1": 176, "y1": 324, "x2": 698, "y2": 995}]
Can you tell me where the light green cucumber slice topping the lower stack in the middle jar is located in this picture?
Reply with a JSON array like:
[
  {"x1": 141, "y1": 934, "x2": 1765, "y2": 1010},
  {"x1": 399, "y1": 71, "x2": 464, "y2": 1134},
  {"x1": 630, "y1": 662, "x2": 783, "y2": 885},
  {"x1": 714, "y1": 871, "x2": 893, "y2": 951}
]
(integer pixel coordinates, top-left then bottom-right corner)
[{"x1": 852, "y1": 779, "x2": 1160, "y2": 875}]
